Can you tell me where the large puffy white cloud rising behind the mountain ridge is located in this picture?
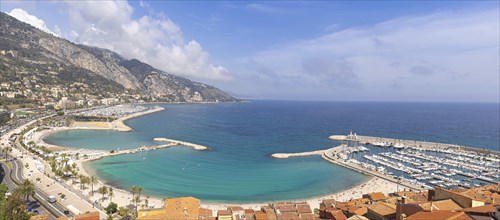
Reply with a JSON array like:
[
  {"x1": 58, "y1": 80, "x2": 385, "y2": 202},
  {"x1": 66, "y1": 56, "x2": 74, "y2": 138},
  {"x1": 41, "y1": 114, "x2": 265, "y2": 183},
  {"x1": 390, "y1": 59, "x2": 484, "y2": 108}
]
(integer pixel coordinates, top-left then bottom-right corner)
[{"x1": 62, "y1": 1, "x2": 232, "y2": 81}]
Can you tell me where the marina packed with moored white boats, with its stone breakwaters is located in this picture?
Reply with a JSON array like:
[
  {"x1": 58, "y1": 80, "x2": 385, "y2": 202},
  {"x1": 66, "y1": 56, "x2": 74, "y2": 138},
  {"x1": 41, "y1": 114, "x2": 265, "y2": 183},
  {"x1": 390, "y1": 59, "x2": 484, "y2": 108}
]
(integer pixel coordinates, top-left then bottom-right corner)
[{"x1": 272, "y1": 132, "x2": 500, "y2": 192}]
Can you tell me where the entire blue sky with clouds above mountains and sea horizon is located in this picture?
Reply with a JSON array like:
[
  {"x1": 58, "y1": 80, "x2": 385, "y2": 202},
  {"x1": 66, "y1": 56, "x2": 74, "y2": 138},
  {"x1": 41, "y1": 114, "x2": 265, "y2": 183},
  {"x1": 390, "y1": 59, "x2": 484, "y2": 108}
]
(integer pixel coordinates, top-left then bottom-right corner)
[{"x1": 0, "y1": 0, "x2": 500, "y2": 103}]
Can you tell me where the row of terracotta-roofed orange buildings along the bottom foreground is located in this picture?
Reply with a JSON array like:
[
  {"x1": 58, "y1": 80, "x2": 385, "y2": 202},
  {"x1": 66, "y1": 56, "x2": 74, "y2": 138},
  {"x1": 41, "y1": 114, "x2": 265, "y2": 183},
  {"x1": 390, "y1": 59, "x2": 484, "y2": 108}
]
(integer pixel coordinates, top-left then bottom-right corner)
[{"x1": 114, "y1": 184, "x2": 500, "y2": 220}]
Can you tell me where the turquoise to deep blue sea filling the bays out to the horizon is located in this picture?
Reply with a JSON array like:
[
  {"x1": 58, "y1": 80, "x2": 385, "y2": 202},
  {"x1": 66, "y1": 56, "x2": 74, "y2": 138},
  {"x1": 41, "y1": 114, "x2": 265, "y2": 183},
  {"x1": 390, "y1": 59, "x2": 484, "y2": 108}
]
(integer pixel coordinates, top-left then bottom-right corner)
[{"x1": 44, "y1": 100, "x2": 500, "y2": 203}]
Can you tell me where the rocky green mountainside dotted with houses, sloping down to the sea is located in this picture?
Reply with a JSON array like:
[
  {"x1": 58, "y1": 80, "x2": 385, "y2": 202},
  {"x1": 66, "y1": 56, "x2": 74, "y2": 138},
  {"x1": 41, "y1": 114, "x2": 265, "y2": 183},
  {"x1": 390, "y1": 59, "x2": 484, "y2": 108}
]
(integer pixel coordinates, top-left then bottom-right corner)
[{"x1": 0, "y1": 13, "x2": 237, "y2": 105}]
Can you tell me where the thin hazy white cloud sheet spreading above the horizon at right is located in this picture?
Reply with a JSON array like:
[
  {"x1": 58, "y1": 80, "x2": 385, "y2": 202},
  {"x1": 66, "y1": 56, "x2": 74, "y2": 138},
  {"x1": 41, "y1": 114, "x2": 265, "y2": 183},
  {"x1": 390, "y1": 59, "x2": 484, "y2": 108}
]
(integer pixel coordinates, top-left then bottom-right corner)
[{"x1": 236, "y1": 10, "x2": 500, "y2": 101}]
